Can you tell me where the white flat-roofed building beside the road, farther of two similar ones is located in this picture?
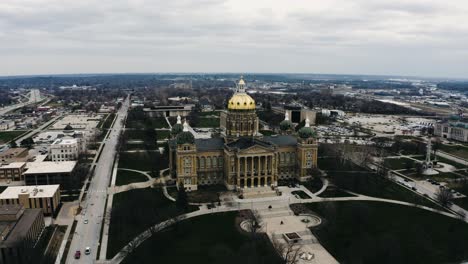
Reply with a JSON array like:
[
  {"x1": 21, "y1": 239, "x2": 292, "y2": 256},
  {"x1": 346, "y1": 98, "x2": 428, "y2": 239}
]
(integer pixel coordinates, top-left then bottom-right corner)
[{"x1": 23, "y1": 161, "x2": 77, "y2": 189}]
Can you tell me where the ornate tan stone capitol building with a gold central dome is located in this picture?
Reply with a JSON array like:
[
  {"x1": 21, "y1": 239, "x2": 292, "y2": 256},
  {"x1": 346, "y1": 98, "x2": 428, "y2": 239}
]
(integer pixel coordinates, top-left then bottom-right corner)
[{"x1": 169, "y1": 79, "x2": 317, "y2": 190}]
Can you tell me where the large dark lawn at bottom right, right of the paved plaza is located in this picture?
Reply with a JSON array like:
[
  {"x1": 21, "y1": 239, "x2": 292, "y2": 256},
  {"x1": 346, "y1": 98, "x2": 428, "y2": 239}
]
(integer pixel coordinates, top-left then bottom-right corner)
[{"x1": 308, "y1": 201, "x2": 468, "y2": 264}]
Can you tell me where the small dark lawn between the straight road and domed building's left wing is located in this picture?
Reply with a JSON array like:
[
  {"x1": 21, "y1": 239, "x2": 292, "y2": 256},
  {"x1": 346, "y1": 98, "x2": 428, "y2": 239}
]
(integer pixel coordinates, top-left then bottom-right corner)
[{"x1": 119, "y1": 151, "x2": 169, "y2": 171}]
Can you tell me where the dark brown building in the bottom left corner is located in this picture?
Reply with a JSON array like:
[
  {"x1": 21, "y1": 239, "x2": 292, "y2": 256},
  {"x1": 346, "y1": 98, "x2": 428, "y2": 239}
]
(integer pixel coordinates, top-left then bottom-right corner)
[{"x1": 0, "y1": 205, "x2": 45, "y2": 264}]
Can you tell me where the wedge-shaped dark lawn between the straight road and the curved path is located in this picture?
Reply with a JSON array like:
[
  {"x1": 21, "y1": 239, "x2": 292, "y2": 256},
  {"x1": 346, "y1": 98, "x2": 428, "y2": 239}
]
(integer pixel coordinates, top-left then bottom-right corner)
[{"x1": 107, "y1": 188, "x2": 197, "y2": 258}]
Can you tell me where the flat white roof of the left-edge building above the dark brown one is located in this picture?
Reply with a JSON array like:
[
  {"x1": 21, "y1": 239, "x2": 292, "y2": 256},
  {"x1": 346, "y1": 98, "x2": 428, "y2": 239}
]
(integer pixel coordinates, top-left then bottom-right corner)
[{"x1": 0, "y1": 184, "x2": 60, "y2": 199}]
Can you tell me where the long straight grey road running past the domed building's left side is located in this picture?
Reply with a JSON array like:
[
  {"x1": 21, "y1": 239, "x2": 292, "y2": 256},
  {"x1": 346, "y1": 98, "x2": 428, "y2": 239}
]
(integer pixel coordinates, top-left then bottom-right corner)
[{"x1": 66, "y1": 98, "x2": 129, "y2": 264}]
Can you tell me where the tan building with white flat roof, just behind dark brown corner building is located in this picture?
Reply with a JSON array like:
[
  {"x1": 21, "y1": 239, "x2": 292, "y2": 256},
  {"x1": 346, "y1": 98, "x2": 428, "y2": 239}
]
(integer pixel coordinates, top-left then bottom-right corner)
[{"x1": 0, "y1": 184, "x2": 60, "y2": 215}]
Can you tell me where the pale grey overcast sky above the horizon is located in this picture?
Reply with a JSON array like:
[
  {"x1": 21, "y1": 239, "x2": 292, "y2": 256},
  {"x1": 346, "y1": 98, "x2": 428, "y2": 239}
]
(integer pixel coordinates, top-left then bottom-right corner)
[{"x1": 0, "y1": 0, "x2": 468, "y2": 78}]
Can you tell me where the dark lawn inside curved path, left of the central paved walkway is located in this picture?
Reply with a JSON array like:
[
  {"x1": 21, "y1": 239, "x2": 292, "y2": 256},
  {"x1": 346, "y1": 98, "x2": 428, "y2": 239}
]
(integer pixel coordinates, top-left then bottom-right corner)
[{"x1": 122, "y1": 212, "x2": 280, "y2": 264}]
